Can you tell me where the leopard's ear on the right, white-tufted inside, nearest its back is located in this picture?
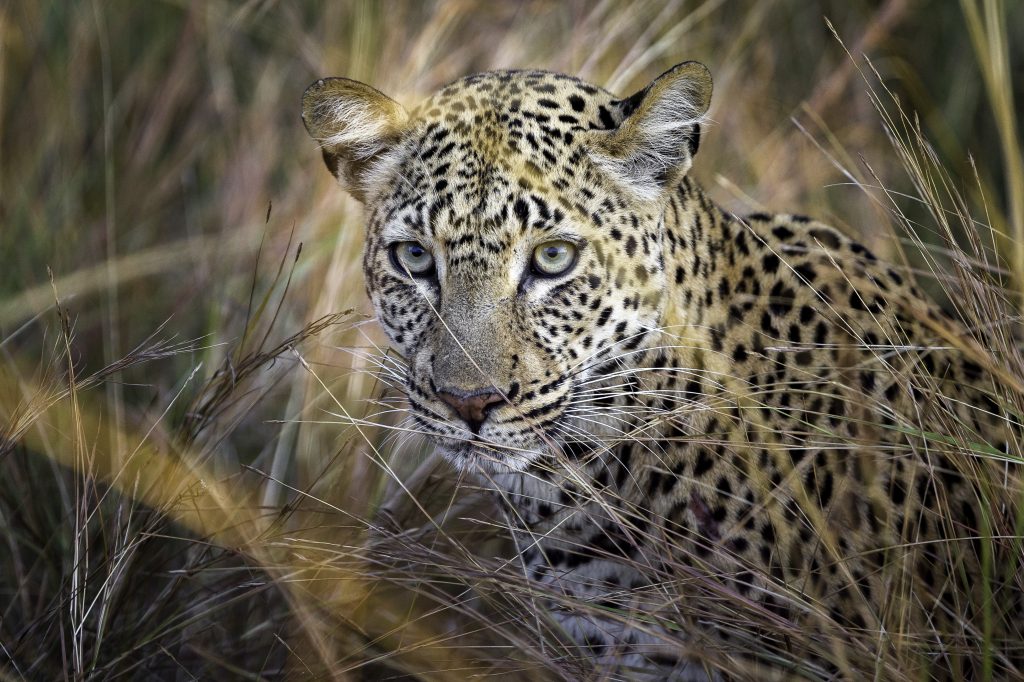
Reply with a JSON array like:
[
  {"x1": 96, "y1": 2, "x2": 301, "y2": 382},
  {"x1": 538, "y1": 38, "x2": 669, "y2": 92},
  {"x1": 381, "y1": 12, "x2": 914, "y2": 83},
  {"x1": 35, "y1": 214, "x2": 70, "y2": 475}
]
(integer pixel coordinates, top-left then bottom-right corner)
[{"x1": 592, "y1": 61, "x2": 712, "y2": 199}]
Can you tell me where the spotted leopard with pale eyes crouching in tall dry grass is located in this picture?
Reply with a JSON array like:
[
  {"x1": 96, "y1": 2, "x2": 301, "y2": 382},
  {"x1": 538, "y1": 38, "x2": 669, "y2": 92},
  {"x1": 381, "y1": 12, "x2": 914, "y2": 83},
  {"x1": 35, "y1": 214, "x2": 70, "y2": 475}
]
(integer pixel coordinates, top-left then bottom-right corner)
[{"x1": 302, "y1": 61, "x2": 1024, "y2": 680}]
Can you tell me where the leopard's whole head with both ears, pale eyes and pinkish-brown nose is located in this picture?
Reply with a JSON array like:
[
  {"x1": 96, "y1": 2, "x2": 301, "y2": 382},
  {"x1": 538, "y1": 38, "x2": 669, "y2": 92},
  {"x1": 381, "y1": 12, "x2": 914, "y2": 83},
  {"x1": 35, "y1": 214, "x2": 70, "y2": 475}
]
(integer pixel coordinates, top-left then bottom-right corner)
[{"x1": 303, "y1": 63, "x2": 710, "y2": 469}]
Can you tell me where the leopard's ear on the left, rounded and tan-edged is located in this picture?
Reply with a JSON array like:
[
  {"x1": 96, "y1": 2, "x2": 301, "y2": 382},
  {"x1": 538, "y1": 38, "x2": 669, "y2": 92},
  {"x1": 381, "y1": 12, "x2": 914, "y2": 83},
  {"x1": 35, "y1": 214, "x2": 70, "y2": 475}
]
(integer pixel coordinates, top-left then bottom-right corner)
[{"x1": 302, "y1": 78, "x2": 409, "y2": 202}]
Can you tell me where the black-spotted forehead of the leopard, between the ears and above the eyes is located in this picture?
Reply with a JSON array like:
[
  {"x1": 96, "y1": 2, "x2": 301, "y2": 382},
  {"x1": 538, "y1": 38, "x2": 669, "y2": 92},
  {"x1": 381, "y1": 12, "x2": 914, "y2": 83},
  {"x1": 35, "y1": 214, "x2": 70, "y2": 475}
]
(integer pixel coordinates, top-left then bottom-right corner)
[{"x1": 371, "y1": 71, "x2": 632, "y2": 233}]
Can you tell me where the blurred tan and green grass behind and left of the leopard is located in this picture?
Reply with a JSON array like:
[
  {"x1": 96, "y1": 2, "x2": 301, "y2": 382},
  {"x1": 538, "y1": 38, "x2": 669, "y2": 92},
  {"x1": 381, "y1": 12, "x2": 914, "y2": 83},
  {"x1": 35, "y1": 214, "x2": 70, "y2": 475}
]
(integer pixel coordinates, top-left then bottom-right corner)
[{"x1": 0, "y1": 0, "x2": 1024, "y2": 679}]
